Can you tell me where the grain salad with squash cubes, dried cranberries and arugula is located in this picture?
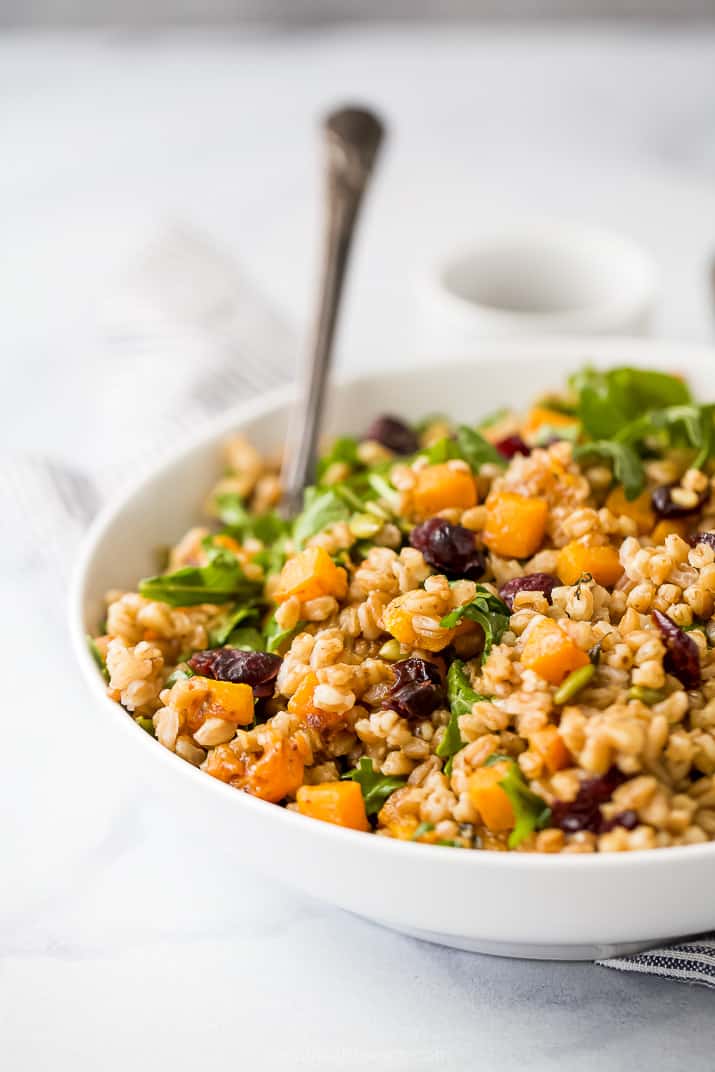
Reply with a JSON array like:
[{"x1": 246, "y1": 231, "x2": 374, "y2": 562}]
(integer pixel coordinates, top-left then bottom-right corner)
[{"x1": 90, "y1": 368, "x2": 715, "y2": 853}]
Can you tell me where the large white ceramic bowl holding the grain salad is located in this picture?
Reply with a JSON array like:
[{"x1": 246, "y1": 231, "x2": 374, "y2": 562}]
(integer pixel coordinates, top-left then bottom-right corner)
[{"x1": 71, "y1": 340, "x2": 715, "y2": 959}]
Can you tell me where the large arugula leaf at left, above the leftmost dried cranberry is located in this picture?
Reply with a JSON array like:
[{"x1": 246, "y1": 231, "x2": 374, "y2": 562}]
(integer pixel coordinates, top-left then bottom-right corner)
[{"x1": 139, "y1": 547, "x2": 260, "y2": 607}]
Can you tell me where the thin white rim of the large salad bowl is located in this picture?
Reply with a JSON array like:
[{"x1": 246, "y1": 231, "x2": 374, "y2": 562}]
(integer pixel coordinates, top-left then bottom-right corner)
[{"x1": 68, "y1": 336, "x2": 715, "y2": 873}]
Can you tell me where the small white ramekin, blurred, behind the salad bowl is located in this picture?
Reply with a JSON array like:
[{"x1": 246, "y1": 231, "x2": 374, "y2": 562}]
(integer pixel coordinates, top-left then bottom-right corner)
[{"x1": 419, "y1": 223, "x2": 657, "y2": 353}]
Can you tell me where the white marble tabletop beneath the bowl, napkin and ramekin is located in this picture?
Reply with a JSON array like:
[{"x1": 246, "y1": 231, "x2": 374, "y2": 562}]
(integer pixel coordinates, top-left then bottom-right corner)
[{"x1": 0, "y1": 27, "x2": 715, "y2": 1072}]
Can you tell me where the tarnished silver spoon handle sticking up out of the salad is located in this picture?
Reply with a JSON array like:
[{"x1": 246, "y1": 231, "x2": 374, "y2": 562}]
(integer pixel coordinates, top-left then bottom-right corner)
[{"x1": 281, "y1": 108, "x2": 384, "y2": 517}]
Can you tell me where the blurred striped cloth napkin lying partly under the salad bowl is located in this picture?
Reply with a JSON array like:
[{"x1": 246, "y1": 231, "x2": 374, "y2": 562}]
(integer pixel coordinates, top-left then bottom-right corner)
[{"x1": 9, "y1": 228, "x2": 715, "y2": 987}]
